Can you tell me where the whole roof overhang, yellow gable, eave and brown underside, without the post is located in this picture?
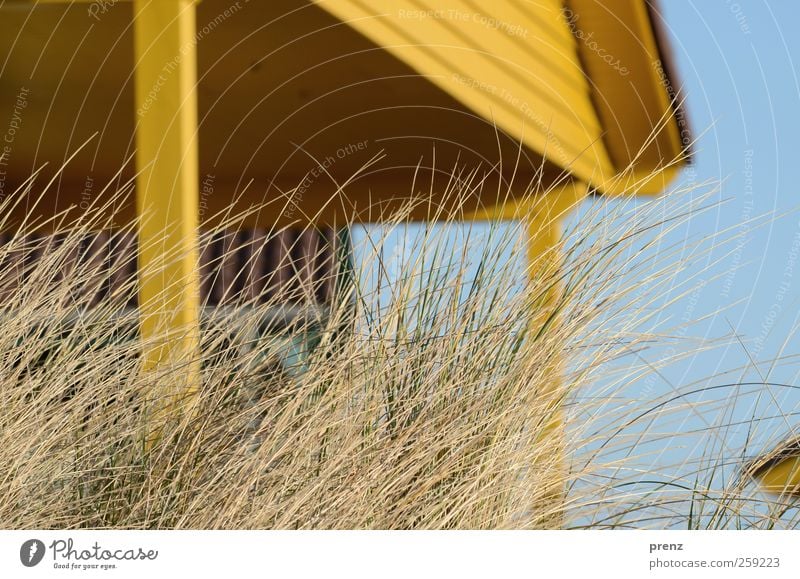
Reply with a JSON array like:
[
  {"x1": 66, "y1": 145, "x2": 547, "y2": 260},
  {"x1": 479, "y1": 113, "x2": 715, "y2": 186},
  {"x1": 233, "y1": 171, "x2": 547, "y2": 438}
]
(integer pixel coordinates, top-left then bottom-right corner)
[{"x1": 0, "y1": 0, "x2": 683, "y2": 228}]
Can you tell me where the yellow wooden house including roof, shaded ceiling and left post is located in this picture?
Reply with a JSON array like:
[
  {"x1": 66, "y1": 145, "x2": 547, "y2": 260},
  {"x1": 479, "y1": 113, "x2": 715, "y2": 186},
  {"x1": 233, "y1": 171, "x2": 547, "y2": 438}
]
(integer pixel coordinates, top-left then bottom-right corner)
[{"x1": 0, "y1": 0, "x2": 691, "y2": 432}]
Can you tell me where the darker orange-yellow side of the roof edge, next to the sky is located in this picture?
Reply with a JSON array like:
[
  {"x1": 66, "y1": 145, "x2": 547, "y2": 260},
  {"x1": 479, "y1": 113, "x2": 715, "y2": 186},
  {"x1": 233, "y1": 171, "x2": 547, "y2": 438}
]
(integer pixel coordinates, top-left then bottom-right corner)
[{"x1": 565, "y1": 0, "x2": 690, "y2": 195}]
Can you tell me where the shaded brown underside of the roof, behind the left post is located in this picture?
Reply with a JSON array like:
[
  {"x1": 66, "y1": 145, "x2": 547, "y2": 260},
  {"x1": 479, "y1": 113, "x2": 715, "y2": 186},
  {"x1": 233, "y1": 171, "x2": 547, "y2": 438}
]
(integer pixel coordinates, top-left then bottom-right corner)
[{"x1": 0, "y1": 0, "x2": 562, "y2": 227}]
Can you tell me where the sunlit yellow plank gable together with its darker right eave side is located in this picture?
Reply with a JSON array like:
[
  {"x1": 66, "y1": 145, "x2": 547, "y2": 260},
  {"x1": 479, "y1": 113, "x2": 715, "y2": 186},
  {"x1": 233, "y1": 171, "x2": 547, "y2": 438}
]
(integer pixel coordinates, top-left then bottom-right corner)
[{"x1": 318, "y1": 0, "x2": 690, "y2": 194}]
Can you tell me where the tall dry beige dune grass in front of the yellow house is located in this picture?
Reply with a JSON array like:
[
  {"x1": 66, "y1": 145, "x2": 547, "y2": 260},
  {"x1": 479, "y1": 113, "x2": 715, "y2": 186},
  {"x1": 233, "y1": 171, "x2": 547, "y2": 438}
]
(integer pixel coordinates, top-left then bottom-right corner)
[{"x1": 0, "y1": 160, "x2": 797, "y2": 529}]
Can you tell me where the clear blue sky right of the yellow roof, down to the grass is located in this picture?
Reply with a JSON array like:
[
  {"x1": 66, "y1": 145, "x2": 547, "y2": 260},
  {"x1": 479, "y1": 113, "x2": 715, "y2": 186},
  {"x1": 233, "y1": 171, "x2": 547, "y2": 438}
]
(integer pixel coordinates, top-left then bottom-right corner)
[{"x1": 560, "y1": 0, "x2": 800, "y2": 516}]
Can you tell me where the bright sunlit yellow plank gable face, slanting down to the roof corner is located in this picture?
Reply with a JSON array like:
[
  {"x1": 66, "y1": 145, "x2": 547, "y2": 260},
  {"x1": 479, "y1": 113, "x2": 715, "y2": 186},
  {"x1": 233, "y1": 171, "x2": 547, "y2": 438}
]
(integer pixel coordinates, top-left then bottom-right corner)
[{"x1": 317, "y1": 0, "x2": 614, "y2": 182}]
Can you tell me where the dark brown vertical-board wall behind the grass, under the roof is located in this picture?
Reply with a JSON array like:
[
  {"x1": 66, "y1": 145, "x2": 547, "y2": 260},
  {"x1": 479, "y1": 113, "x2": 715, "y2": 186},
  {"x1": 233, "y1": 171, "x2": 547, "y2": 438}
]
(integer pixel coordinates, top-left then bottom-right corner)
[{"x1": 0, "y1": 228, "x2": 340, "y2": 309}]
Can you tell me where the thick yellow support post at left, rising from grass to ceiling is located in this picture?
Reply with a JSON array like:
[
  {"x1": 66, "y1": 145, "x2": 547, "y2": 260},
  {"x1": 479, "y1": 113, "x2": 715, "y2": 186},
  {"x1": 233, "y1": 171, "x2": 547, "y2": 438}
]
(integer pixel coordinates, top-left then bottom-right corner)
[{"x1": 134, "y1": 0, "x2": 200, "y2": 444}]
